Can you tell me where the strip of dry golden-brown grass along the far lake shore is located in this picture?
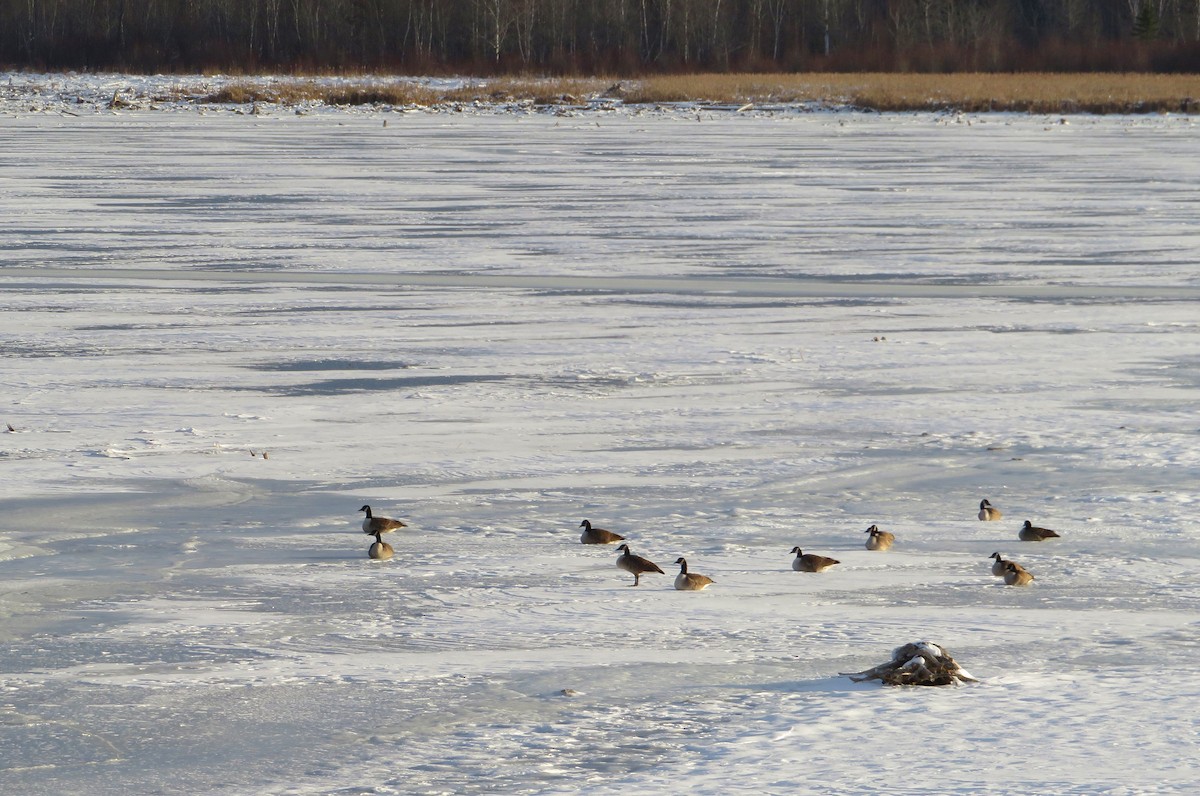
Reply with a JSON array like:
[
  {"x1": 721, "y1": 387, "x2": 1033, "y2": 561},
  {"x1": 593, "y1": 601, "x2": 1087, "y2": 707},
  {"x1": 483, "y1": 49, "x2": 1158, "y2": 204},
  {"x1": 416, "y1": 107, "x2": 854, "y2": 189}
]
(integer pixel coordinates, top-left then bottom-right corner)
[{"x1": 204, "y1": 73, "x2": 1200, "y2": 113}]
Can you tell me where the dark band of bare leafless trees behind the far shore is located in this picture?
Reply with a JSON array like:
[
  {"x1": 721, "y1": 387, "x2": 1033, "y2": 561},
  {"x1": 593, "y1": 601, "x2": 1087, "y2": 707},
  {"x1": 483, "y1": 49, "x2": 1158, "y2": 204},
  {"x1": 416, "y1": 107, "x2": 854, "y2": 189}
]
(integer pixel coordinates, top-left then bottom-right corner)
[{"x1": 0, "y1": 0, "x2": 1200, "y2": 74}]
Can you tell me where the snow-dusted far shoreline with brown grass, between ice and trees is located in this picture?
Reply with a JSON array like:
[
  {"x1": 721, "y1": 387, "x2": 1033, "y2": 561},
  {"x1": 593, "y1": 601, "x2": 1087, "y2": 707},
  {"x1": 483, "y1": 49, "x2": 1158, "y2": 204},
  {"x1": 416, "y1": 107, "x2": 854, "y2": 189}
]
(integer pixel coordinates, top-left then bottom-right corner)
[{"x1": 7, "y1": 71, "x2": 1200, "y2": 116}]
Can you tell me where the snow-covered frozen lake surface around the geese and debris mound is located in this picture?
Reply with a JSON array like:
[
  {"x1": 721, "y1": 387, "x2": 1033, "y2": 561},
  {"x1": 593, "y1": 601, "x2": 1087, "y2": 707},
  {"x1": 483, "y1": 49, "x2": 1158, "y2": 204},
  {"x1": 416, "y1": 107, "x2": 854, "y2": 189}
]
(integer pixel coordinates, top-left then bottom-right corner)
[{"x1": 0, "y1": 102, "x2": 1200, "y2": 795}]
